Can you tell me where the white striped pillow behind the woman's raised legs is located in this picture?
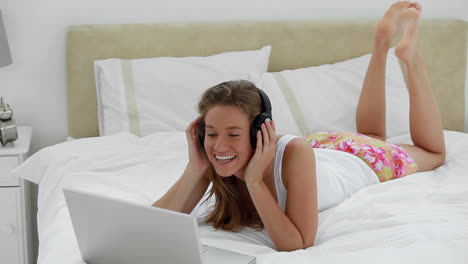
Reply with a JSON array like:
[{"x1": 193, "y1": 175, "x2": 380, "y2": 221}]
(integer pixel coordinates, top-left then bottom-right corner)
[{"x1": 260, "y1": 49, "x2": 409, "y2": 137}]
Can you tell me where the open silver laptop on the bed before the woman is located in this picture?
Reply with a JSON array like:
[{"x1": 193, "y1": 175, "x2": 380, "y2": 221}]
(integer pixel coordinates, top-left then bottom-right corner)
[{"x1": 64, "y1": 188, "x2": 255, "y2": 264}]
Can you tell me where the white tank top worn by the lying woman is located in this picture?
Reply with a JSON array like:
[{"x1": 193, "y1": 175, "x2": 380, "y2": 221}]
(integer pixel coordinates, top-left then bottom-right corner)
[{"x1": 273, "y1": 135, "x2": 380, "y2": 212}]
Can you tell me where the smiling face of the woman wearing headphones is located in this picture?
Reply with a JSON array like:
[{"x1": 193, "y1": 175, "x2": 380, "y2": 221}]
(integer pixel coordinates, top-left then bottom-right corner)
[{"x1": 204, "y1": 105, "x2": 254, "y2": 179}]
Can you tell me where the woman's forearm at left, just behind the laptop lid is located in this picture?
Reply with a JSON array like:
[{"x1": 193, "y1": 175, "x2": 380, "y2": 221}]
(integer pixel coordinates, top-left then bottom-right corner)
[{"x1": 153, "y1": 166, "x2": 210, "y2": 214}]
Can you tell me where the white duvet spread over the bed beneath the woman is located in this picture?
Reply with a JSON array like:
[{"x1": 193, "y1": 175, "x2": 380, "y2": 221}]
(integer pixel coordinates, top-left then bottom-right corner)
[{"x1": 11, "y1": 131, "x2": 468, "y2": 264}]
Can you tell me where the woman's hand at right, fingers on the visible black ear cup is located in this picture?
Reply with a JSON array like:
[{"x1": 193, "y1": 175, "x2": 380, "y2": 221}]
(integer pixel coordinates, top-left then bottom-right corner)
[{"x1": 244, "y1": 119, "x2": 276, "y2": 185}]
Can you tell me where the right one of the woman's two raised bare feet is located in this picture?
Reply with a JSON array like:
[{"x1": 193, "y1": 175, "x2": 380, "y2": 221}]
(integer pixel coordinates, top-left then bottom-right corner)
[{"x1": 395, "y1": 4, "x2": 421, "y2": 64}]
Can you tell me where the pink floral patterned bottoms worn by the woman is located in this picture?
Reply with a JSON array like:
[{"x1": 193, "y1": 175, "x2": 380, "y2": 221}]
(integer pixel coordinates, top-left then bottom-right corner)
[{"x1": 304, "y1": 132, "x2": 418, "y2": 182}]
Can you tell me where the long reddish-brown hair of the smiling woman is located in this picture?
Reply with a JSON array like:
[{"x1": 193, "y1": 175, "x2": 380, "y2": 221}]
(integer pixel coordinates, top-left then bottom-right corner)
[{"x1": 198, "y1": 80, "x2": 264, "y2": 231}]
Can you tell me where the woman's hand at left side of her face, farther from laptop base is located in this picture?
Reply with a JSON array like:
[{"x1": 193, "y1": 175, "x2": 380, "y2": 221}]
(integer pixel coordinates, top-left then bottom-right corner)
[{"x1": 185, "y1": 116, "x2": 210, "y2": 174}]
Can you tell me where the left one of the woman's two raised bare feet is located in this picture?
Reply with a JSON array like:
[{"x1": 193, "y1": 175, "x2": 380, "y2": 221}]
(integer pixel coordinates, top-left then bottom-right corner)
[{"x1": 375, "y1": 1, "x2": 415, "y2": 47}]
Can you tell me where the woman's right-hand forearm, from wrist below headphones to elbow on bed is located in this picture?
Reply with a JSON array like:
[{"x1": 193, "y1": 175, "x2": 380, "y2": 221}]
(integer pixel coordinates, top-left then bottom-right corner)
[{"x1": 247, "y1": 181, "x2": 304, "y2": 251}]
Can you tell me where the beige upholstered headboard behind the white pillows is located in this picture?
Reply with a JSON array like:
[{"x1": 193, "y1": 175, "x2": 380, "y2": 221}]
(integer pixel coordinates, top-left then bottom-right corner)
[{"x1": 67, "y1": 19, "x2": 468, "y2": 138}]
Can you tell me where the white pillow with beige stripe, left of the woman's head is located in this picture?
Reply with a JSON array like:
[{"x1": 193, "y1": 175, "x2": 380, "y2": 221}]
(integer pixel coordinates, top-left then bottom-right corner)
[{"x1": 94, "y1": 46, "x2": 271, "y2": 136}]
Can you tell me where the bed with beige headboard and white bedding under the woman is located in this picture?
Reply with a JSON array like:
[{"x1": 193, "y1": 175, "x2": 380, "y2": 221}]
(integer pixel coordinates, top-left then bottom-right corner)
[{"x1": 15, "y1": 19, "x2": 468, "y2": 264}]
